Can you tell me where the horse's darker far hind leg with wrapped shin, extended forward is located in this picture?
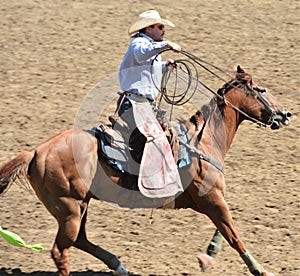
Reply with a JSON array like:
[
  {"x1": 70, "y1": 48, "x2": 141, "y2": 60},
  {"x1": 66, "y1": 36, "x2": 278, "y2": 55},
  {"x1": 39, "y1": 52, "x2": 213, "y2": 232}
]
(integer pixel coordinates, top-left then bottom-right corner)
[{"x1": 74, "y1": 208, "x2": 128, "y2": 276}]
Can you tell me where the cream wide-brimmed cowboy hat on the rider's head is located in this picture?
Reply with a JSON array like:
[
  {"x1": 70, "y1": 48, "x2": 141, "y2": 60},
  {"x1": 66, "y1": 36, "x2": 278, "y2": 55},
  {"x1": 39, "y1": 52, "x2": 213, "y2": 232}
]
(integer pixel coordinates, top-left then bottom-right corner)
[{"x1": 128, "y1": 10, "x2": 175, "y2": 35}]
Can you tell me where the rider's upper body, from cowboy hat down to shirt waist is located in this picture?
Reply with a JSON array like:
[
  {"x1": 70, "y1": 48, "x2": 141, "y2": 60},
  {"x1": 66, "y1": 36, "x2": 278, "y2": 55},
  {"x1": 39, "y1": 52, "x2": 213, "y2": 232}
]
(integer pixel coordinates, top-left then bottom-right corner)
[{"x1": 119, "y1": 10, "x2": 181, "y2": 101}]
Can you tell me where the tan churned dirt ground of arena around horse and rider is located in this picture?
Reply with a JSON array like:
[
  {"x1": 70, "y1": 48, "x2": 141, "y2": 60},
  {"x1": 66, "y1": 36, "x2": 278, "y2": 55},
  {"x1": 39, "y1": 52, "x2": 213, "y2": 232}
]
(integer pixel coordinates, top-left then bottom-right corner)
[{"x1": 0, "y1": 0, "x2": 300, "y2": 276}]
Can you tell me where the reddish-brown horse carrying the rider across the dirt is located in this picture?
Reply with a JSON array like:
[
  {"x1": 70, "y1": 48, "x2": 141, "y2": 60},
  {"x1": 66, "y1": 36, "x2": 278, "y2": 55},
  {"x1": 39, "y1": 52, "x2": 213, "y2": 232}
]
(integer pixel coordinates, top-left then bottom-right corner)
[{"x1": 0, "y1": 67, "x2": 291, "y2": 276}]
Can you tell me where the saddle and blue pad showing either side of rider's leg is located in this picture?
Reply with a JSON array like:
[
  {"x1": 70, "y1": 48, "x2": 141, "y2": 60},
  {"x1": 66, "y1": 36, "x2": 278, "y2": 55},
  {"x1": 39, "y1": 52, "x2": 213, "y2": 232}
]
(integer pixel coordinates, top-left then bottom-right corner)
[{"x1": 88, "y1": 111, "x2": 205, "y2": 173}]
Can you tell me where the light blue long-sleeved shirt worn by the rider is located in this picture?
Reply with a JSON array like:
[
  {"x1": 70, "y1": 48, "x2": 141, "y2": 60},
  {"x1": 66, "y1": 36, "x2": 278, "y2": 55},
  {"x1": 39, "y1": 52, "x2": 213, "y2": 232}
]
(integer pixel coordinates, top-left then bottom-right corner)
[{"x1": 119, "y1": 33, "x2": 168, "y2": 100}]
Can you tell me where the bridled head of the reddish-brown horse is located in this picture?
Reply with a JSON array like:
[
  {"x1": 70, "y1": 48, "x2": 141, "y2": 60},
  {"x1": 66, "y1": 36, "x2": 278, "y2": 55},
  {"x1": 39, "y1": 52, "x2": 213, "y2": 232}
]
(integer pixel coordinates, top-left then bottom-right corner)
[{"x1": 218, "y1": 66, "x2": 292, "y2": 129}]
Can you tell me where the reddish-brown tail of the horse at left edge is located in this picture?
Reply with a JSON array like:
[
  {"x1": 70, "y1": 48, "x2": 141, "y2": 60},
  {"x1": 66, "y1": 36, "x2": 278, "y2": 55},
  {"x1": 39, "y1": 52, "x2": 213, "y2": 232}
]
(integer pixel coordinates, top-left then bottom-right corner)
[{"x1": 0, "y1": 151, "x2": 35, "y2": 194}]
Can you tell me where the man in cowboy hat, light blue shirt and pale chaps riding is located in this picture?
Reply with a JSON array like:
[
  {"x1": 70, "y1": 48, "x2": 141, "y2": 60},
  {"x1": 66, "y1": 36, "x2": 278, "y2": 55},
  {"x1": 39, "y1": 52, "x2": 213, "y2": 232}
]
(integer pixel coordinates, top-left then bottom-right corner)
[{"x1": 117, "y1": 10, "x2": 182, "y2": 197}]
